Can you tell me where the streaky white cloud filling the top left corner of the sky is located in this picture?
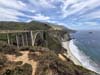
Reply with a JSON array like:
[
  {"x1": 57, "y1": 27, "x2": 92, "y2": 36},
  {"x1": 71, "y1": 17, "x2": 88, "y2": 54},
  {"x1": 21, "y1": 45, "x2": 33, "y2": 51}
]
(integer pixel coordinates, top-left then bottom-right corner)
[{"x1": 0, "y1": 0, "x2": 35, "y2": 12}]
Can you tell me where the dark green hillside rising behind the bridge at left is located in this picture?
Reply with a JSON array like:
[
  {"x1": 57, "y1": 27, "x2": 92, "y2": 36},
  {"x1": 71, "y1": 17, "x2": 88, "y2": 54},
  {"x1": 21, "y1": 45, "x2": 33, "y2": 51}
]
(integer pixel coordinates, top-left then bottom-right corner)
[{"x1": 0, "y1": 21, "x2": 51, "y2": 30}]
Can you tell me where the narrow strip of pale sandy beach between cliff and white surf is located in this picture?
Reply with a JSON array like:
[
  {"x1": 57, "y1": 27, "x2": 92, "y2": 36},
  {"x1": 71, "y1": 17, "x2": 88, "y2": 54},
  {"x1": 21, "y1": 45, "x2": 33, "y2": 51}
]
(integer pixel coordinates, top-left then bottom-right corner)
[{"x1": 62, "y1": 41, "x2": 82, "y2": 66}]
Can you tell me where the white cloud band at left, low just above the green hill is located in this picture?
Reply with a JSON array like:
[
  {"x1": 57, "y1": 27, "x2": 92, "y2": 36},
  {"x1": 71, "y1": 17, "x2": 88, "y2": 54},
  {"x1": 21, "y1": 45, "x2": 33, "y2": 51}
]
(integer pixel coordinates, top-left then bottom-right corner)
[{"x1": 0, "y1": 7, "x2": 35, "y2": 21}]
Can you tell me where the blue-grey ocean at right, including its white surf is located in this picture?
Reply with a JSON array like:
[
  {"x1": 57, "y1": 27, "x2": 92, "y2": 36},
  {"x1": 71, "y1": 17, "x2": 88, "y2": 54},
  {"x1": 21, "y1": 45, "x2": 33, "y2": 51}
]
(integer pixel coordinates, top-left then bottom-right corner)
[{"x1": 69, "y1": 30, "x2": 100, "y2": 74}]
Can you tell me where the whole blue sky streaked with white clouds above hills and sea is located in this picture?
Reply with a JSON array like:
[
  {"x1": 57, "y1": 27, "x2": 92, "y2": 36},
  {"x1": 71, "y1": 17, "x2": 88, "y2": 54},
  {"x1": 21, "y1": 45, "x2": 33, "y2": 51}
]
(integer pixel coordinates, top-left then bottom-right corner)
[{"x1": 0, "y1": 0, "x2": 100, "y2": 30}]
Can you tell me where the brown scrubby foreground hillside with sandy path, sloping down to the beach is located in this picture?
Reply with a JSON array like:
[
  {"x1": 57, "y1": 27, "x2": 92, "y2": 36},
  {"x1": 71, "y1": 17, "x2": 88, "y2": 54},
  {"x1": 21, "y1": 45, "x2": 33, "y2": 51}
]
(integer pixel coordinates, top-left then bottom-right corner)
[{"x1": 0, "y1": 44, "x2": 97, "y2": 75}]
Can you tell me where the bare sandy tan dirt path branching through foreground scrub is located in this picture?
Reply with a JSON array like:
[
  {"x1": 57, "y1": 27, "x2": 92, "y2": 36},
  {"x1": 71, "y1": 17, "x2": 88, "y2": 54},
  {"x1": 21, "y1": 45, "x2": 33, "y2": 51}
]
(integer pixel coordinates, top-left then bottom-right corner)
[{"x1": 6, "y1": 51, "x2": 37, "y2": 75}]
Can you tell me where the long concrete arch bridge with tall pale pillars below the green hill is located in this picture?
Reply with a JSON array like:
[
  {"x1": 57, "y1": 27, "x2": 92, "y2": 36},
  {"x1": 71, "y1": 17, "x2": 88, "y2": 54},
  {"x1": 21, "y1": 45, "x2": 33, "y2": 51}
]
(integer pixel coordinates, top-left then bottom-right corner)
[{"x1": 0, "y1": 30, "x2": 69, "y2": 48}]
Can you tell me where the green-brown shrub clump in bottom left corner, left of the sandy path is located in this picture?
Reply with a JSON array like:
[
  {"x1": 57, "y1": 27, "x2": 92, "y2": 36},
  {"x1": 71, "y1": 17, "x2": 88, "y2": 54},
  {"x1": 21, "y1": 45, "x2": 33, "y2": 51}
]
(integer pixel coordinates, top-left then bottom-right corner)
[{"x1": 2, "y1": 63, "x2": 32, "y2": 75}]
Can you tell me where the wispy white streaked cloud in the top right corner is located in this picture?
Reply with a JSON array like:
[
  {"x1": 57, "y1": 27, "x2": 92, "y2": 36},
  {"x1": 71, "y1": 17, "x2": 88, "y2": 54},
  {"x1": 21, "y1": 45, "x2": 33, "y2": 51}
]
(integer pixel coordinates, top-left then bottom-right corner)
[{"x1": 62, "y1": 0, "x2": 100, "y2": 18}]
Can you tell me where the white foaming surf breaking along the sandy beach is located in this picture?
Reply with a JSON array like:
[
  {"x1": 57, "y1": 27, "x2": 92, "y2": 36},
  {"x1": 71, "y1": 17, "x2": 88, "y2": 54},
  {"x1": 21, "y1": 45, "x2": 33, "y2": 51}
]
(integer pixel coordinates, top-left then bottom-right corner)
[{"x1": 69, "y1": 40, "x2": 100, "y2": 74}]
